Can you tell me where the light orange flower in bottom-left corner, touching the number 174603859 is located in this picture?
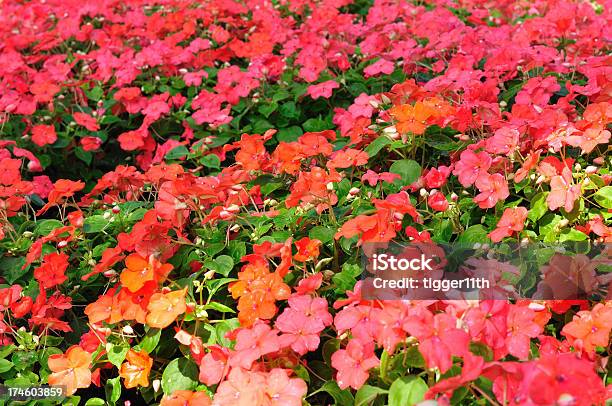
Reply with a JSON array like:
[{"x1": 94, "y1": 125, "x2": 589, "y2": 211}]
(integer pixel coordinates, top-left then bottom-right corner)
[{"x1": 47, "y1": 346, "x2": 91, "y2": 396}]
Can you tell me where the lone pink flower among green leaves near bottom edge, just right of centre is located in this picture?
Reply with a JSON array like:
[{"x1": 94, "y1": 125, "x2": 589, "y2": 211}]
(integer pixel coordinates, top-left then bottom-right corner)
[{"x1": 331, "y1": 340, "x2": 380, "y2": 389}]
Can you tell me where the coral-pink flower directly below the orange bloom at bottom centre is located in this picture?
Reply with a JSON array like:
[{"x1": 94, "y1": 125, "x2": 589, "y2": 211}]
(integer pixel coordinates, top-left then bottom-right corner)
[{"x1": 229, "y1": 323, "x2": 280, "y2": 369}]
